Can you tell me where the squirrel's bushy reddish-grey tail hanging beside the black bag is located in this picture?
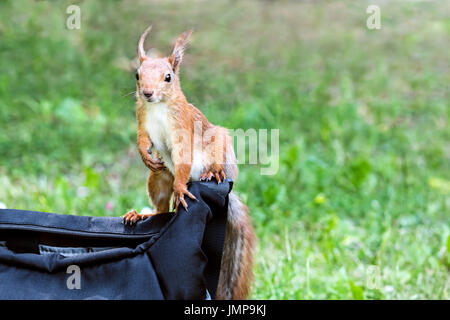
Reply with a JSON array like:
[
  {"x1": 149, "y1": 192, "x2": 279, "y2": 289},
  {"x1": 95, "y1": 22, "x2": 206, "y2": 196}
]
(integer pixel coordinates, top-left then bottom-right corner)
[{"x1": 216, "y1": 192, "x2": 255, "y2": 300}]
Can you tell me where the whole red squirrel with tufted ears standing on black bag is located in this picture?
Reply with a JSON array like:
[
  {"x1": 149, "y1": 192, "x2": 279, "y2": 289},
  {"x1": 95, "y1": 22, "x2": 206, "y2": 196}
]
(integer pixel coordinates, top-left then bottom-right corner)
[{"x1": 124, "y1": 26, "x2": 255, "y2": 299}]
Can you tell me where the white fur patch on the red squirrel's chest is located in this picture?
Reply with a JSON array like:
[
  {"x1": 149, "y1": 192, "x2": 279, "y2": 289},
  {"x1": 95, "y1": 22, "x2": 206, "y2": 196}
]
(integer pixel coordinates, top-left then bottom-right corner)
[{"x1": 145, "y1": 103, "x2": 174, "y2": 172}]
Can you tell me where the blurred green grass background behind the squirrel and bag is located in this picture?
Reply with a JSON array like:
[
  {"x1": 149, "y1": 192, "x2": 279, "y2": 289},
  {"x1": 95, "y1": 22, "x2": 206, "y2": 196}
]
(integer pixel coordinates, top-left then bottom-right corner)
[{"x1": 0, "y1": 0, "x2": 450, "y2": 299}]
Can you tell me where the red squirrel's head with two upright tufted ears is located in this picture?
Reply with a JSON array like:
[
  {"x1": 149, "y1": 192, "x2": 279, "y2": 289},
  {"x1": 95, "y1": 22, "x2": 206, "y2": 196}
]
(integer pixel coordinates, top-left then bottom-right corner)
[{"x1": 136, "y1": 26, "x2": 192, "y2": 103}]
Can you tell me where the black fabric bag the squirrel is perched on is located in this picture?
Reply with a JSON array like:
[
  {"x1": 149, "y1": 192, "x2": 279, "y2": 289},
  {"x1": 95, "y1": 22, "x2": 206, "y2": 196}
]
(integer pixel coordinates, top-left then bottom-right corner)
[{"x1": 0, "y1": 181, "x2": 232, "y2": 299}]
